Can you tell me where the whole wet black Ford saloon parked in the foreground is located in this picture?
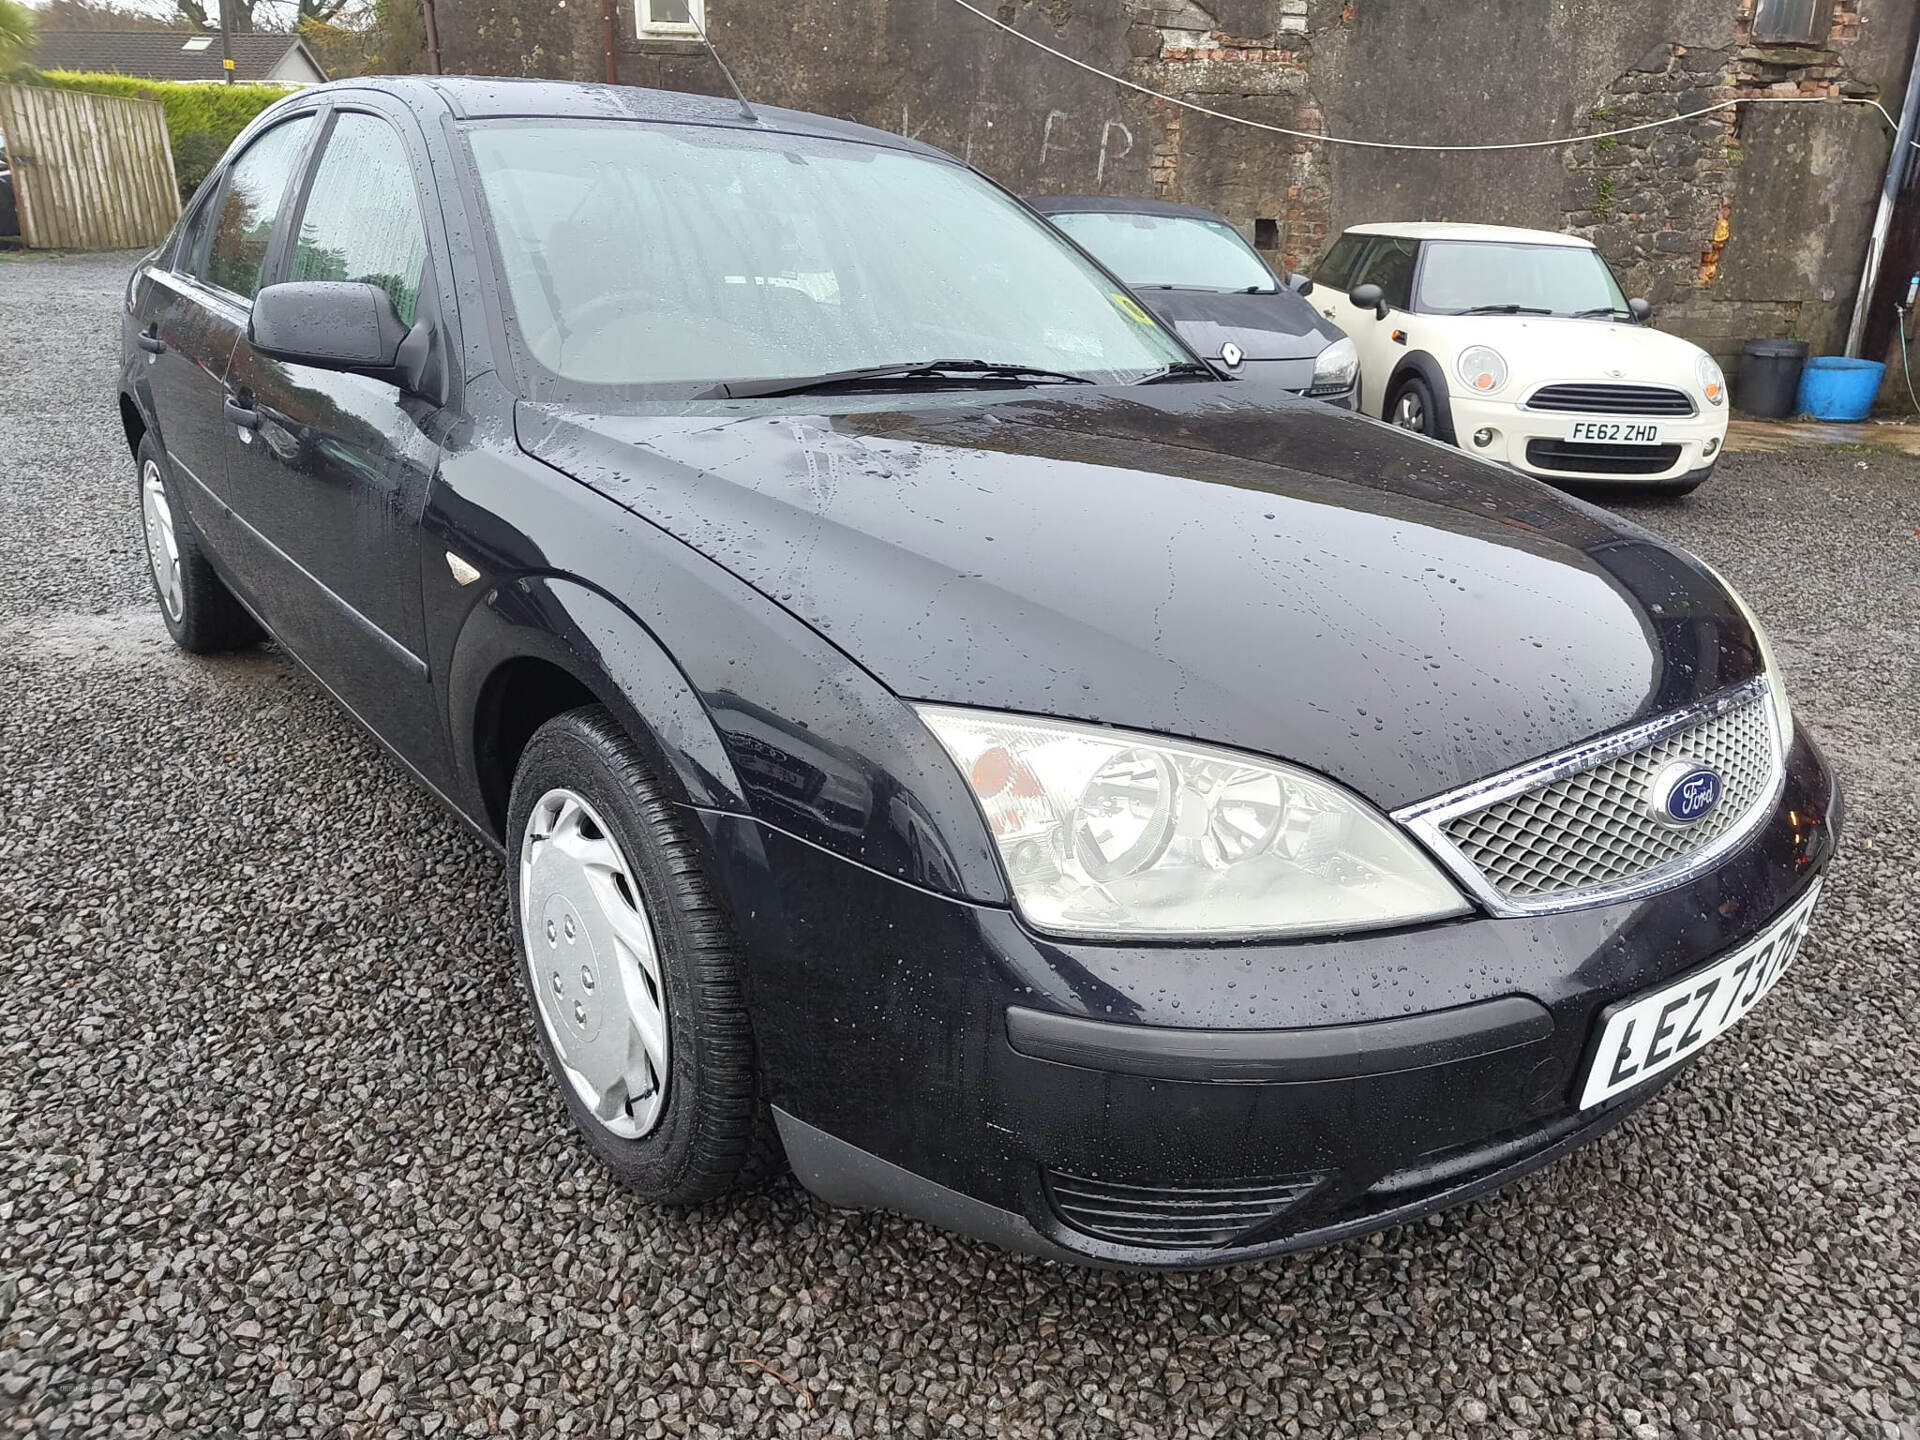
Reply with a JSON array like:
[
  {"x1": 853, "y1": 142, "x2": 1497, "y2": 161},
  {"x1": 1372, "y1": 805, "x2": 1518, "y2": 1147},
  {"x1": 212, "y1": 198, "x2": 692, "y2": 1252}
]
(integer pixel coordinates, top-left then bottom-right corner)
[{"x1": 119, "y1": 79, "x2": 1839, "y2": 1265}]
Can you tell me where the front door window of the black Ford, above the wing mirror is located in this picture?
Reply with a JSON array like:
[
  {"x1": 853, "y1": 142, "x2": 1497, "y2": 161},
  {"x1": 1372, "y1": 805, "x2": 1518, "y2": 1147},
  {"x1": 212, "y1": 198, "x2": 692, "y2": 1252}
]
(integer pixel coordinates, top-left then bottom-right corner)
[{"x1": 286, "y1": 111, "x2": 426, "y2": 324}]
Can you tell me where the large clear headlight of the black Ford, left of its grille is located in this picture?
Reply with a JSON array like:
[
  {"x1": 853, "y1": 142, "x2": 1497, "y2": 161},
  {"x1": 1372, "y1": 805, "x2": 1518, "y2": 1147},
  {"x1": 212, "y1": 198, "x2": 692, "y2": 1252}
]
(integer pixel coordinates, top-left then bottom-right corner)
[{"x1": 920, "y1": 705, "x2": 1467, "y2": 937}]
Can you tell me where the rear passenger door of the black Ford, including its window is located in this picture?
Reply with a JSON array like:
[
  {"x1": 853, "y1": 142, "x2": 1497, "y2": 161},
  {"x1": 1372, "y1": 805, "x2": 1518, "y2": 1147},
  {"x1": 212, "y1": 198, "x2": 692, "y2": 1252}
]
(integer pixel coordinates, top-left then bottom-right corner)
[{"x1": 136, "y1": 115, "x2": 313, "y2": 541}]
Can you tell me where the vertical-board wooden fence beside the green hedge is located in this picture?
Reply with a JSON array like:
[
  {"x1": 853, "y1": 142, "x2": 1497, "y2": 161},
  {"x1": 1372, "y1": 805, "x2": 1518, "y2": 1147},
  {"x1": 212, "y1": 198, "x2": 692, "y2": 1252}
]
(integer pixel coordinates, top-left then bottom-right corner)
[{"x1": 0, "y1": 84, "x2": 180, "y2": 250}]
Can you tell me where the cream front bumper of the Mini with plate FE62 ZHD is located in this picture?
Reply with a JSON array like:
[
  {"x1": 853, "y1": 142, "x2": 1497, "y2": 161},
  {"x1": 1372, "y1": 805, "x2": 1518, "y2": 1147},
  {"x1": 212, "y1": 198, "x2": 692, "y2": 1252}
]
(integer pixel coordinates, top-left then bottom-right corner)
[{"x1": 1448, "y1": 390, "x2": 1726, "y2": 486}]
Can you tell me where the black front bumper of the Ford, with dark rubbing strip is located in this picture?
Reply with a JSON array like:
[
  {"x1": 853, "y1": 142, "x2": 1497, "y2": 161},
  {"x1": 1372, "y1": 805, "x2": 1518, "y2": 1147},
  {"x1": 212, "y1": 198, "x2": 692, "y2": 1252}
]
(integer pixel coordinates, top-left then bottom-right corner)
[{"x1": 703, "y1": 735, "x2": 1841, "y2": 1267}]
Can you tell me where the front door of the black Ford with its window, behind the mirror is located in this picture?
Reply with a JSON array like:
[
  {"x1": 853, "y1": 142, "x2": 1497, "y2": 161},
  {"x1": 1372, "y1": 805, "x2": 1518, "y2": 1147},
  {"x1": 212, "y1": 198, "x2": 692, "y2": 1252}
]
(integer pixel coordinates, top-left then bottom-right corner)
[{"x1": 227, "y1": 106, "x2": 445, "y2": 770}]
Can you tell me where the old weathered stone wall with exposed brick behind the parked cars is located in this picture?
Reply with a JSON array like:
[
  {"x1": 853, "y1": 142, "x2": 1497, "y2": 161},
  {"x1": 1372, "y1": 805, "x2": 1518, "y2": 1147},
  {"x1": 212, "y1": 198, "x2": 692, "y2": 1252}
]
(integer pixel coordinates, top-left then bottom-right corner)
[{"x1": 440, "y1": 0, "x2": 1920, "y2": 378}]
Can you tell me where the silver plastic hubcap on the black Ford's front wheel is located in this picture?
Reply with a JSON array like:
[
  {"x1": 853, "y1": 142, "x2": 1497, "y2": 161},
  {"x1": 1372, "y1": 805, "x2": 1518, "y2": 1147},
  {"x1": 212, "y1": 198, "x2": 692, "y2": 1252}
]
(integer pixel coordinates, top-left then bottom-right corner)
[{"x1": 520, "y1": 789, "x2": 668, "y2": 1140}]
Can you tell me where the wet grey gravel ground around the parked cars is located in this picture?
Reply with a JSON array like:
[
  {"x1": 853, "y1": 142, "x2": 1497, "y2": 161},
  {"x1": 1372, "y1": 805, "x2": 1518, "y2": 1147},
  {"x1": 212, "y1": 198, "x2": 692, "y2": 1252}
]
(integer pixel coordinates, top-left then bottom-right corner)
[{"x1": 0, "y1": 255, "x2": 1920, "y2": 1440}]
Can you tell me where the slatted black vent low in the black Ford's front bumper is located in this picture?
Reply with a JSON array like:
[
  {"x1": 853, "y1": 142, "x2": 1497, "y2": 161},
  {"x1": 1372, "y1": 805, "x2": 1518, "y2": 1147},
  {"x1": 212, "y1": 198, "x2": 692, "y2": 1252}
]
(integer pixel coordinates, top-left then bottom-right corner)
[{"x1": 1046, "y1": 1171, "x2": 1323, "y2": 1250}]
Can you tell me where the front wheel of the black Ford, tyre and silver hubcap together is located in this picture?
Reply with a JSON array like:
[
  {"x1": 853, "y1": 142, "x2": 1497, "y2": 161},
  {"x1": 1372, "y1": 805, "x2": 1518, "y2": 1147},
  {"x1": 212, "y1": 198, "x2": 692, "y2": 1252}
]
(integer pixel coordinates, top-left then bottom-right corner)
[{"x1": 507, "y1": 705, "x2": 783, "y2": 1206}]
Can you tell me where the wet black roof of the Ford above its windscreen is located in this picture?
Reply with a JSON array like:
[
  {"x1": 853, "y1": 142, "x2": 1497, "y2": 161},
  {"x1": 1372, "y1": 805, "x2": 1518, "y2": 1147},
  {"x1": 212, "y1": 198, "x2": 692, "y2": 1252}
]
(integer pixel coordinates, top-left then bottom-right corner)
[{"x1": 278, "y1": 75, "x2": 952, "y2": 159}]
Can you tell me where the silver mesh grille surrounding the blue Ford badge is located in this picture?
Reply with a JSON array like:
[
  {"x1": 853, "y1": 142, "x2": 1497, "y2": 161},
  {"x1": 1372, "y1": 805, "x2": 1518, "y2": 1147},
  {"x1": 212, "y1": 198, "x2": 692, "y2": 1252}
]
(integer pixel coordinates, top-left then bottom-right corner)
[{"x1": 1442, "y1": 699, "x2": 1776, "y2": 900}]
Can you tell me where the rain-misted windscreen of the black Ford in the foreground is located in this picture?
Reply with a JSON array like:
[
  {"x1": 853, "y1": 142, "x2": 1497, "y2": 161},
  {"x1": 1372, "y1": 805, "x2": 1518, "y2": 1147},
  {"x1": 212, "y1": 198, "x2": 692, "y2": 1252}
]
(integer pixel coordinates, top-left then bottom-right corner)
[{"x1": 467, "y1": 121, "x2": 1188, "y2": 396}]
